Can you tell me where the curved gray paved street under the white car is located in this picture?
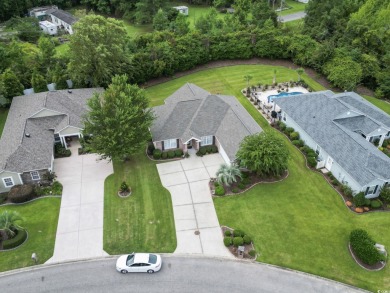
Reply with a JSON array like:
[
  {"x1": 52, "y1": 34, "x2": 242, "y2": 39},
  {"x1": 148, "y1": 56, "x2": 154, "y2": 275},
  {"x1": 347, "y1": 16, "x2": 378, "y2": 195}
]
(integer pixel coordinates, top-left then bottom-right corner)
[{"x1": 0, "y1": 256, "x2": 362, "y2": 293}]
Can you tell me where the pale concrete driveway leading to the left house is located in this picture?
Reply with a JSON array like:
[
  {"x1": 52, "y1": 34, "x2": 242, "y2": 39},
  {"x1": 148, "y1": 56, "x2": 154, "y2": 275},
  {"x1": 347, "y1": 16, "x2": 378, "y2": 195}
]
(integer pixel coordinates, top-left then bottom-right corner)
[{"x1": 46, "y1": 142, "x2": 113, "y2": 263}]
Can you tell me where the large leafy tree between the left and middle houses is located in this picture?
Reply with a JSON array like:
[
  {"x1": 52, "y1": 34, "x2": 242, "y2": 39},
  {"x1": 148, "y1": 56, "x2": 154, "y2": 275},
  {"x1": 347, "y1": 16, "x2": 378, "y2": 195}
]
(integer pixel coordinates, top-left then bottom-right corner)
[{"x1": 83, "y1": 75, "x2": 153, "y2": 159}]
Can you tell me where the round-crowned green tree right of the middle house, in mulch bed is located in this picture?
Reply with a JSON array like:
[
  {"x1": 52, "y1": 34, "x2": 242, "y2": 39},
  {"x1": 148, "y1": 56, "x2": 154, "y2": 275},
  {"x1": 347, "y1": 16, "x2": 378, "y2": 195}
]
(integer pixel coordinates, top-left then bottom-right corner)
[{"x1": 236, "y1": 131, "x2": 289, "y2": 176}]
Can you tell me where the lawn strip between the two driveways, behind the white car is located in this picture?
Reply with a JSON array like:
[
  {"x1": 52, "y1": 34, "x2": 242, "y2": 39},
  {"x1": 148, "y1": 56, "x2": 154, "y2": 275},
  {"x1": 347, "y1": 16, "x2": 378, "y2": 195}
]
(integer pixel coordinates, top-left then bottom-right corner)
[{"x1": 104, "y1": 152, "x2": 176, "y2": 254}]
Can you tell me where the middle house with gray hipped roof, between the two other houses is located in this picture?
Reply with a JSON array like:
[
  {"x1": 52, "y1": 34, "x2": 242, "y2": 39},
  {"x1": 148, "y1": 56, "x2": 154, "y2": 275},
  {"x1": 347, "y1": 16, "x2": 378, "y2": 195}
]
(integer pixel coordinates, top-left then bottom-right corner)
[{"x1": 150, "y1": 83, "x2": 262, "y2": 164}]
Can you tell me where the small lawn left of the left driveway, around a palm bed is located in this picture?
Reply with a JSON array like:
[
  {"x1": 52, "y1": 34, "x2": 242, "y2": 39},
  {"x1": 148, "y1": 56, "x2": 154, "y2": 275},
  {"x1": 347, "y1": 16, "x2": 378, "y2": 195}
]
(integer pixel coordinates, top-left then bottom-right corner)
[{"x1": 0, "y1": 198, "x2": 61, "y2": 271}]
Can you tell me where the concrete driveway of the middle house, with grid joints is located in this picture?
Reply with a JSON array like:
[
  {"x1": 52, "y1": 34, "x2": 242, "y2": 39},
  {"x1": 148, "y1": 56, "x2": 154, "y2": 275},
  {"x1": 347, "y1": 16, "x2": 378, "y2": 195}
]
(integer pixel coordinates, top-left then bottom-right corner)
[{"x1": 157, "y1": 154, "x2": 233, "y2": 258}]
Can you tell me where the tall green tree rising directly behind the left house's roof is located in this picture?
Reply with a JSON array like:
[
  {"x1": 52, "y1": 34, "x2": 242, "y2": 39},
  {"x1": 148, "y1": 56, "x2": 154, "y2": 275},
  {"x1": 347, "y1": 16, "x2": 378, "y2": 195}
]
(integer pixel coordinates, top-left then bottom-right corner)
[{"x1": 69, "y1": 15, "x2": 129, "y2": 86}]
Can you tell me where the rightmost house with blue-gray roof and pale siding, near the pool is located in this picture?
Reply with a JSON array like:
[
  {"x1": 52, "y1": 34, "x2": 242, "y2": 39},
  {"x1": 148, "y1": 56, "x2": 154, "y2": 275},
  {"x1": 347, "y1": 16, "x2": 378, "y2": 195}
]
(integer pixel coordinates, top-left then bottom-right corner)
[{"x1": 275, "y1": 91, "x2": 390, "y2": 198}]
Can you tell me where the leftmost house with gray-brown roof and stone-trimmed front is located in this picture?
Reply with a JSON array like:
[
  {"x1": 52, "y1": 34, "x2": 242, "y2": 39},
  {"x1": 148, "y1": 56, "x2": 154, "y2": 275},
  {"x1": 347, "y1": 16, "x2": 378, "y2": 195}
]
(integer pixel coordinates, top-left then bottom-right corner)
[{"x1": 0, "y1": 88, "x2": 103, "y2": 192}]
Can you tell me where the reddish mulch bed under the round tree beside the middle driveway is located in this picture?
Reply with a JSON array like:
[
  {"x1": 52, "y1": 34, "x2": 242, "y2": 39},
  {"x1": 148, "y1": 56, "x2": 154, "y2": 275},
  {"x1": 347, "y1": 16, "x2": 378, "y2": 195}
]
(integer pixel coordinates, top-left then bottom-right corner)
[{"x1": 209, "y1": 170, "x2": 288, "y2": 196}]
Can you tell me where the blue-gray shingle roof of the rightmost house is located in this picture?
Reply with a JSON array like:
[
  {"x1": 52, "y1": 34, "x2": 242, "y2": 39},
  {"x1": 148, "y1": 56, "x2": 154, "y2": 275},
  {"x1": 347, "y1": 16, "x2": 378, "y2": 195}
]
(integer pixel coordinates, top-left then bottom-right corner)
[{"x1": 275, "y1": 91, "x2": 390, "y2": 186}]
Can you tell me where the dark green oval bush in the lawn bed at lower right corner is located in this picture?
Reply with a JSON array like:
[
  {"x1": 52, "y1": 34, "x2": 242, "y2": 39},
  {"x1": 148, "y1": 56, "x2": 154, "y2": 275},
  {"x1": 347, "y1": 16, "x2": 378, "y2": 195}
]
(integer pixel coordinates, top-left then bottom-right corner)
[{"x1": 349, "y1": 229, "x2": 383, "y2": 265}]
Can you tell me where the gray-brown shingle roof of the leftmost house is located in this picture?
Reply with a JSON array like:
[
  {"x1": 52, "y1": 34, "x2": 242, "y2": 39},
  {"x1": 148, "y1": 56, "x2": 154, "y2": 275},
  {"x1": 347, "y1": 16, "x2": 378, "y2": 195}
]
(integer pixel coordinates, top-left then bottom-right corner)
[{"x1": 0, "y1": 88, "x2": 103, "y2": 173}]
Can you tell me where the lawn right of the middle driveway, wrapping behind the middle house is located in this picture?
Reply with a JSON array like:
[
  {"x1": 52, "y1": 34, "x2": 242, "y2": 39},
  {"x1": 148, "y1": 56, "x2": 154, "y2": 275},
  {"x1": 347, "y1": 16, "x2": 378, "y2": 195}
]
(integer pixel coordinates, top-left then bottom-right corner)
[{"x1": 147, "y1": 65, "x2": 390, "y2": 290}]
